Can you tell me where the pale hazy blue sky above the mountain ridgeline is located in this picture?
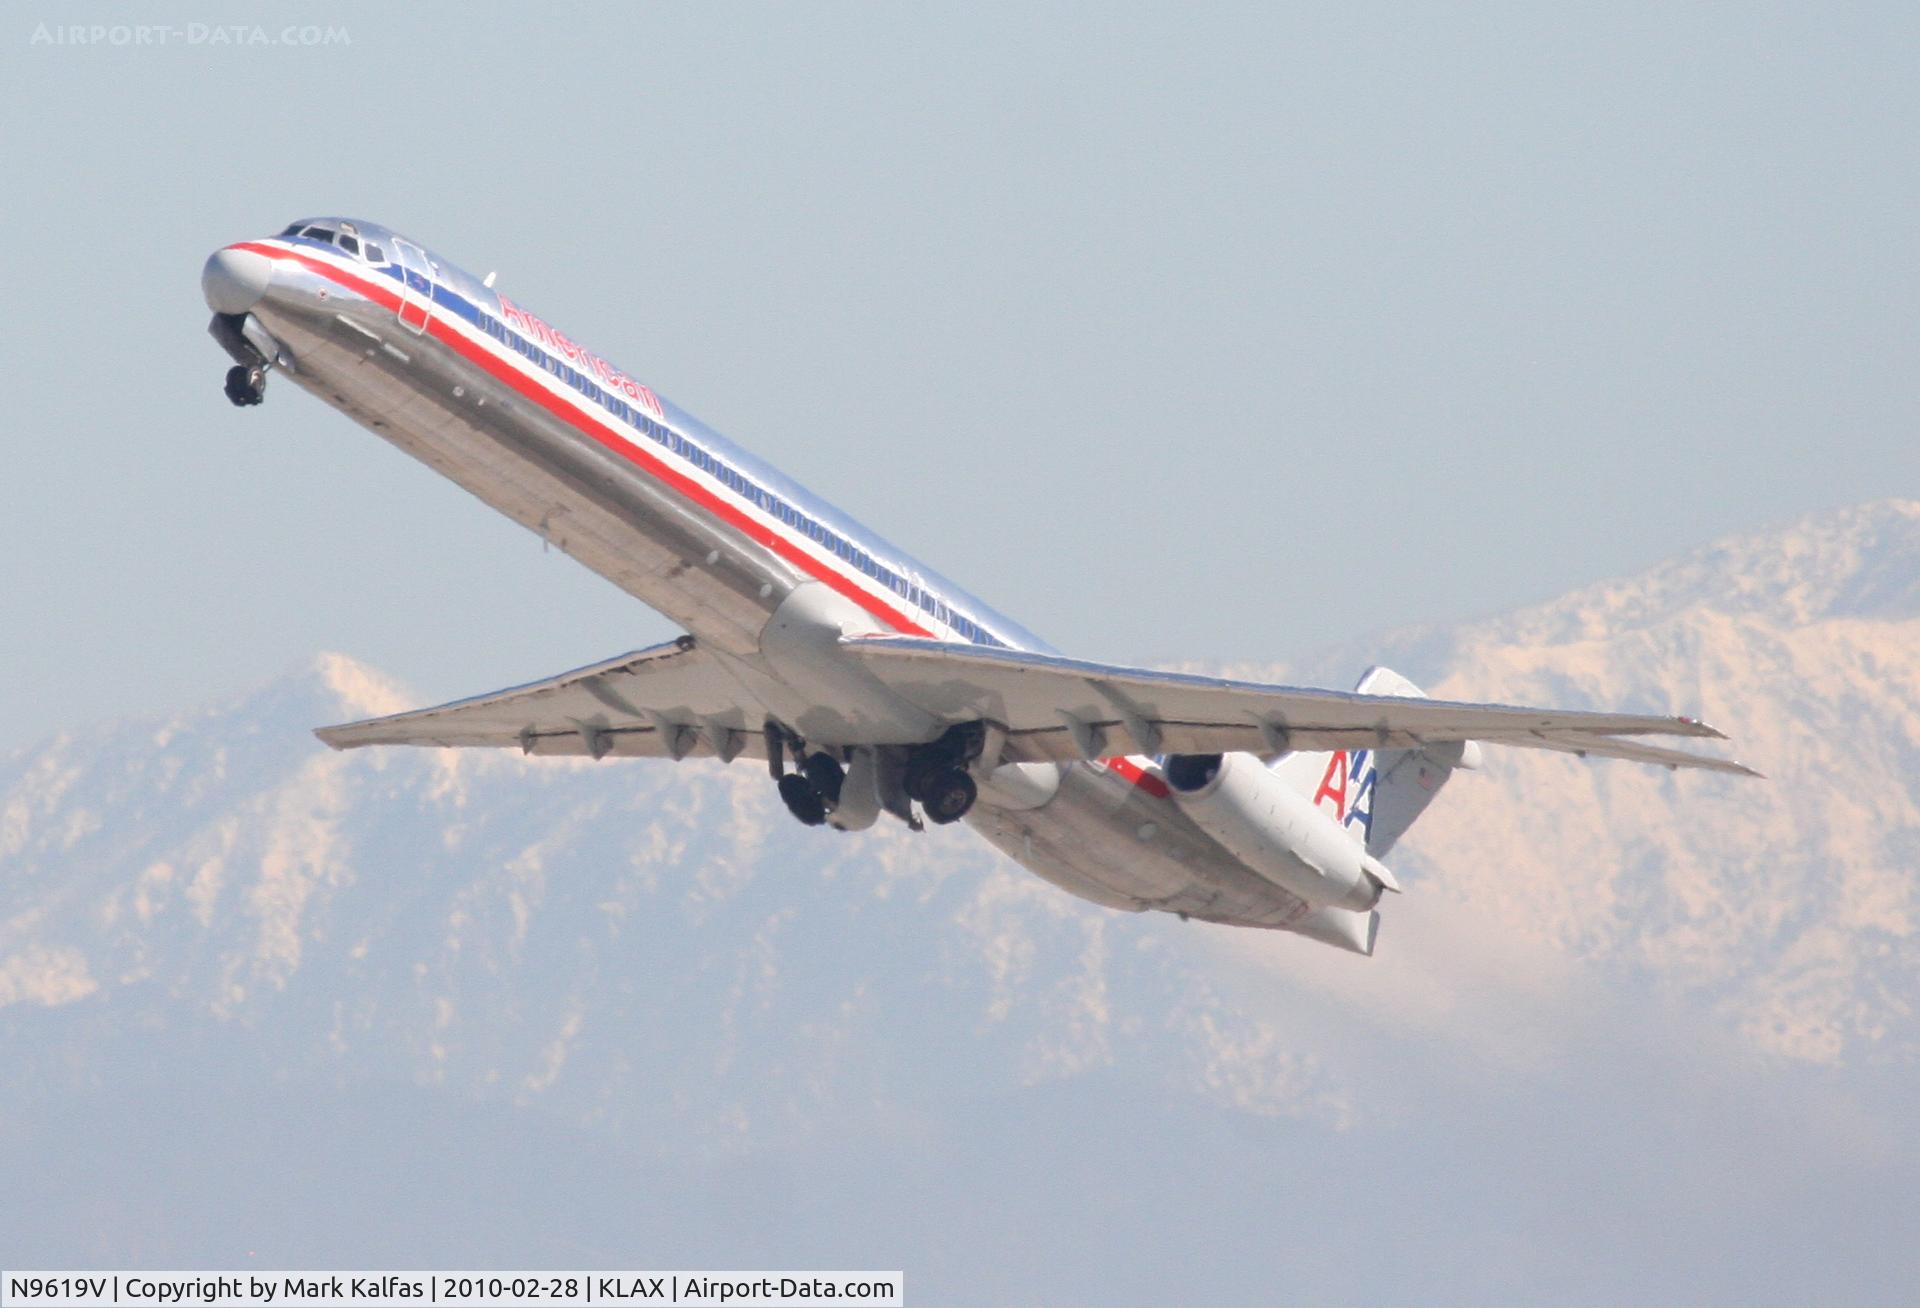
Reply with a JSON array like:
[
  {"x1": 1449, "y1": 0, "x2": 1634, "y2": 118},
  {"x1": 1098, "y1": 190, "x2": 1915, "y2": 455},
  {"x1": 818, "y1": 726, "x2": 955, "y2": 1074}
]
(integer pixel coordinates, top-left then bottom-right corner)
[{"x1": 0, "y1": 4, "x2": 1920, "y2": 747}]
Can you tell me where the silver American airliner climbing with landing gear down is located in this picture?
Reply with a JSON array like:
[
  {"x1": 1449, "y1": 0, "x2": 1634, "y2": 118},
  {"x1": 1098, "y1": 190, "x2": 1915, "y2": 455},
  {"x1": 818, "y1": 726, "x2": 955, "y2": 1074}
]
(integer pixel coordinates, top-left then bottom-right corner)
[{"x1": 202, "y1": 217, "x2": 1759, "y2": 955}]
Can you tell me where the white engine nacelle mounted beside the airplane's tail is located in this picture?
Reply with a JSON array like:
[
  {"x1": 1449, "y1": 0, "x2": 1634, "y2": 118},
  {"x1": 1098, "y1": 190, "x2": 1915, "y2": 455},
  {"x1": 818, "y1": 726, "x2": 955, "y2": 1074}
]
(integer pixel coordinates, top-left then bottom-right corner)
[{"x1": 1164, "y1": 753, "x2": 1400, "y2": 912}]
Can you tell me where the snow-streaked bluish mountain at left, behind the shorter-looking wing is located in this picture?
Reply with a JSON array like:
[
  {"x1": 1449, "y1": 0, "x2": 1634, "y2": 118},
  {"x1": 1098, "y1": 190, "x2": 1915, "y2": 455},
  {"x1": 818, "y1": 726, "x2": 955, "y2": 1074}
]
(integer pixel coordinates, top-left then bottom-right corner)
[{"x1": 0, "y1": 655, "x2": 1279, "y2": 1143}]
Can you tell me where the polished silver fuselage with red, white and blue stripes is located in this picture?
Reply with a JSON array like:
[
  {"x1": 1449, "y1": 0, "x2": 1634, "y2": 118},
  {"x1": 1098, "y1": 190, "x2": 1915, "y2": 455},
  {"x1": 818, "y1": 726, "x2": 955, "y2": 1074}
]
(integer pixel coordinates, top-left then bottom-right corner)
[{"x1": 214, "y1": 223, "x2": 1308, "y2": 928}]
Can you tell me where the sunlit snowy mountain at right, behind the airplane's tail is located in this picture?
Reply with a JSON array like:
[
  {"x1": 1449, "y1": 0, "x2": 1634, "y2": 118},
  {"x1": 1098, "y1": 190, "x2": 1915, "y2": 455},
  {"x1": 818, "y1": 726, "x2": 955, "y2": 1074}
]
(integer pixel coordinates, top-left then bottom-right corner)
[{"x1": 1290, "y1": 501, "x2": 1920, "y2": 1064}]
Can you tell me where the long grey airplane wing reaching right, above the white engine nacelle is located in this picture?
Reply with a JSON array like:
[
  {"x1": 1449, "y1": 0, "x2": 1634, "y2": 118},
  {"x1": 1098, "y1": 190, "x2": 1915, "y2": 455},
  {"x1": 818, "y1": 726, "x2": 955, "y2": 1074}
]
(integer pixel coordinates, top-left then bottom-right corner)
[{"x1": 843, "y1": 636, "x2": 1759, "y2": 776}]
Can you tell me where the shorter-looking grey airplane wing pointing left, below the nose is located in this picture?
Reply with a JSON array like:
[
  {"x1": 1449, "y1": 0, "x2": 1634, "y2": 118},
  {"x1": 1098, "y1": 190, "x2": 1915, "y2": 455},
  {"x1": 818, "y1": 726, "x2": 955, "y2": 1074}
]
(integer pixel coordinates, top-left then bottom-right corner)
[{"x1": 315, "y1": 636, "x2": 766, "y2": 761}]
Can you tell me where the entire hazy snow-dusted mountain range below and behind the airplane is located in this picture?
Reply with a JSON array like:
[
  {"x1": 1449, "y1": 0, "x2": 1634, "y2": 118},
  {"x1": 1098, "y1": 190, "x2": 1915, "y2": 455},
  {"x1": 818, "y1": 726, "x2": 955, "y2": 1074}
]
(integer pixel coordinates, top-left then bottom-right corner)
[{"x1": 0, "y1": 505, "x2": 1920, "y2": 1304}]
